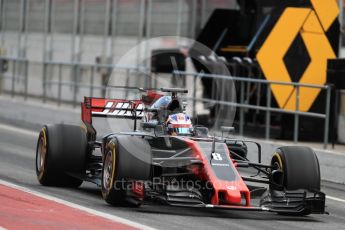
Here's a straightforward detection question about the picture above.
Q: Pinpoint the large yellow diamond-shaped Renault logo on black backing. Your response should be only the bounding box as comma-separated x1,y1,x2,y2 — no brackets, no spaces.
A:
257,0,339,111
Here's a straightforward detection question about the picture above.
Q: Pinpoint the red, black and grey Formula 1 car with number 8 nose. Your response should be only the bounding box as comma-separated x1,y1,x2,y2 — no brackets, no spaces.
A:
36,87,325,215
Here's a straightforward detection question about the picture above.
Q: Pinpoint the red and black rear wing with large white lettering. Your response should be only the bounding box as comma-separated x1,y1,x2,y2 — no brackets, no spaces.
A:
81,97,144,125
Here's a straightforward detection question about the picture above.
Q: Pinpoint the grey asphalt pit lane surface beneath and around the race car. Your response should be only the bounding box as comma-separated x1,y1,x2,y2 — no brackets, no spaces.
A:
0,126,345,230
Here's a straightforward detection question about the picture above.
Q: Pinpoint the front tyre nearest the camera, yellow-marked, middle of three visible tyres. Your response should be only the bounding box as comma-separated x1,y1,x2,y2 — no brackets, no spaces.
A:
102,136,152,207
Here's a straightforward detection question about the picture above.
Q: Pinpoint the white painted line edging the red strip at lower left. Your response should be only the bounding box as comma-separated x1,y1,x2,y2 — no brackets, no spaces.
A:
0,179,154,230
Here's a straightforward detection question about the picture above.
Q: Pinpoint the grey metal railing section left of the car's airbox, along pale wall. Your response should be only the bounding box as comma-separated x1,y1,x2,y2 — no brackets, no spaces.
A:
0,57,149,106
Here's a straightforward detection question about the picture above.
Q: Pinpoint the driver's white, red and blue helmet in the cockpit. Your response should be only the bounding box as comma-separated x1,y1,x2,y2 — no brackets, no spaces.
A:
166,113,193,136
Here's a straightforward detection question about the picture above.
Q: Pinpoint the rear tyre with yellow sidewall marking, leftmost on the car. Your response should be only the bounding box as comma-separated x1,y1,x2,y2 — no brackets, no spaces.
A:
36,124,88,187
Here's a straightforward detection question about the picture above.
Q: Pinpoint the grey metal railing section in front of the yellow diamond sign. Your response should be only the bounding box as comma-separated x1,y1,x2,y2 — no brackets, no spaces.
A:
174,71,333,149
